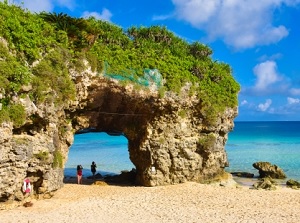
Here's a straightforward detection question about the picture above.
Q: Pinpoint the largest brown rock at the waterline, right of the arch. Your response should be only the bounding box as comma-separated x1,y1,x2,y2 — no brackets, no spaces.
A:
252,162,286,179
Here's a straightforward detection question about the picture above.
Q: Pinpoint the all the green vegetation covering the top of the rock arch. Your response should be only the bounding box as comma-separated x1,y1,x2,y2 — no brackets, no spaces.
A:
0,1,240,126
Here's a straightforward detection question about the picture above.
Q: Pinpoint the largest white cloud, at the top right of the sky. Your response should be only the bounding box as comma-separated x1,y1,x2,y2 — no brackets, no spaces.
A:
172,0,300,49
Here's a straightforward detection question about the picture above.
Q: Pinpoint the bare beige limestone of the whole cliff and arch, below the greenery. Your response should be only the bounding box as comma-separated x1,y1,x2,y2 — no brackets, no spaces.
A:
0,66,237,201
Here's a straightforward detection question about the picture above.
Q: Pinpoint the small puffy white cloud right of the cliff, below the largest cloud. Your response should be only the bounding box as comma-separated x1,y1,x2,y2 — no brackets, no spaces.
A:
253,60,281,91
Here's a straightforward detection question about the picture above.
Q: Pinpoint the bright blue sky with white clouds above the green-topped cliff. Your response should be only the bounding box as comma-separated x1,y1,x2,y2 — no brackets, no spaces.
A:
9,0,300,121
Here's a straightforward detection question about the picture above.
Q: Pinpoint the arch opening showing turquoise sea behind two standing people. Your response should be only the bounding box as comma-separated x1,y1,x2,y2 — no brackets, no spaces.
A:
64,131,135,179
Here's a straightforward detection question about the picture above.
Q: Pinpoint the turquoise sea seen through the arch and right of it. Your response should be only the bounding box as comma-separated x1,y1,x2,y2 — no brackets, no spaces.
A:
64,121,300,180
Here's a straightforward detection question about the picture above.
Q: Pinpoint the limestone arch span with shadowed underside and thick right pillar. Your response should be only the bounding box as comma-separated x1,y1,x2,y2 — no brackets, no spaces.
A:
69,78,237,186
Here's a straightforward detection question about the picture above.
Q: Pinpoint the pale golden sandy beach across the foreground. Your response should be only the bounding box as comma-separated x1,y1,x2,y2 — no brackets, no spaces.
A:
0,179,300,223
